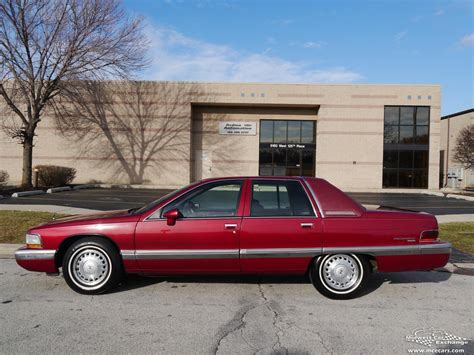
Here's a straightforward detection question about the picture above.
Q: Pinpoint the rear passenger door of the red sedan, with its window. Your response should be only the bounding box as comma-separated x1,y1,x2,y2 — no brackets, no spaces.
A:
240,179,323,273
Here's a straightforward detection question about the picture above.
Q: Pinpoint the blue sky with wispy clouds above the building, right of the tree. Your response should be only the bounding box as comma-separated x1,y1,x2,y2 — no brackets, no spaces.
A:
125,0,474,114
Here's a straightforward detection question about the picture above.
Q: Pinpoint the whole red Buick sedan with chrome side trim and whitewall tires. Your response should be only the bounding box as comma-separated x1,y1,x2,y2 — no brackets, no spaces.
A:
15,177,451,299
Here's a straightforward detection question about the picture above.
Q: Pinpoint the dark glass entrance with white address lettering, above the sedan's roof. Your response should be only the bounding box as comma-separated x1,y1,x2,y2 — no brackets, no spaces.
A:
259,120,316,176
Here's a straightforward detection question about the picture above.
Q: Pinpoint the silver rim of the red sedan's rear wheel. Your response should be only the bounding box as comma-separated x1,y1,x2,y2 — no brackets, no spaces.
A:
320,254,363,293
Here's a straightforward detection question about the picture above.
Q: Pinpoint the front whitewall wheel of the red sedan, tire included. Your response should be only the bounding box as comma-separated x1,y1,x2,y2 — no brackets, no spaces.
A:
62,237,123,295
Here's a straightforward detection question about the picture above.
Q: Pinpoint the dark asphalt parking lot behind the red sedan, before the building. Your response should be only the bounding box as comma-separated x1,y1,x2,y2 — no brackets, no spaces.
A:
0,188,474,215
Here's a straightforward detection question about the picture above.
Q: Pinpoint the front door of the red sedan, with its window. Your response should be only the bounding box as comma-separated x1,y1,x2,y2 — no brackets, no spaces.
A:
135,179,244,273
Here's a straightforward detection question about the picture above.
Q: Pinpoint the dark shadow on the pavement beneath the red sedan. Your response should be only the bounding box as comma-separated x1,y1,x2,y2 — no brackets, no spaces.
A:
110,271,451,296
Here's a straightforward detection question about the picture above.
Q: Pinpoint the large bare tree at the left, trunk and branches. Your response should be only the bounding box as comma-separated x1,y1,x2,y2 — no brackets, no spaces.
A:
0,0,146,186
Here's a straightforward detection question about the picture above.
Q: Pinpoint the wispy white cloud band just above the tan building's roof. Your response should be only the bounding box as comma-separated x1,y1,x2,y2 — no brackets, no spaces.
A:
145,26,363,83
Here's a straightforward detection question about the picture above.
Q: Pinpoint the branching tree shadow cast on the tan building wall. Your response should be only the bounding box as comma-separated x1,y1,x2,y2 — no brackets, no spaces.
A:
55,81,198,184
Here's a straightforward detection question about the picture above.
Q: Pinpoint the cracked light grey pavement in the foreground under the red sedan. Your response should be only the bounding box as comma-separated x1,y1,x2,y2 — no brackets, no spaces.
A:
0,259,474,354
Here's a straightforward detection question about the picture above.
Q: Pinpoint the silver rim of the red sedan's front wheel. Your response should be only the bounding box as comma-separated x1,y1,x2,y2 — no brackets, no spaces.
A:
68,246,112,290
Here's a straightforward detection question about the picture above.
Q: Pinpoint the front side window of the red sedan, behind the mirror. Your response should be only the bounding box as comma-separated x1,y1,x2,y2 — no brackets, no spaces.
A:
161,181,242,218
